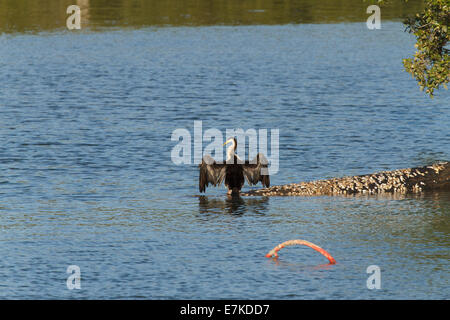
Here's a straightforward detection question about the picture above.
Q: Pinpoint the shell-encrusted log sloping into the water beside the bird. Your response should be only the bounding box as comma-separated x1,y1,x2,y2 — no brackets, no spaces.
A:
241,162,450,196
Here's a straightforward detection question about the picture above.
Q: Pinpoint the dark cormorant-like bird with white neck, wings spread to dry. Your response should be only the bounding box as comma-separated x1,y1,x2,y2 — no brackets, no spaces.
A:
199,138,270,194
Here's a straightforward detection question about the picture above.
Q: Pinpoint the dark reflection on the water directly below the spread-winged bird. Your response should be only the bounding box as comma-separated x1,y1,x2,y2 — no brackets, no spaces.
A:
198,196,269,214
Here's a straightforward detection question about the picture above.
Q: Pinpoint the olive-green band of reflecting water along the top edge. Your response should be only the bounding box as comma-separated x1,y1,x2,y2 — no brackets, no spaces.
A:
0,0,423,33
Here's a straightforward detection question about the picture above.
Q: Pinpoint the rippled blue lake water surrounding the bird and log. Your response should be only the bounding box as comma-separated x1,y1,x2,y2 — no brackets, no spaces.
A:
0,22,450,299
